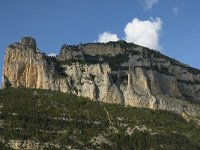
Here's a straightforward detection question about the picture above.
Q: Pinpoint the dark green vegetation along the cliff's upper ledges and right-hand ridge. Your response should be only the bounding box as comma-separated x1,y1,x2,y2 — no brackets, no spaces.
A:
54,41,200,75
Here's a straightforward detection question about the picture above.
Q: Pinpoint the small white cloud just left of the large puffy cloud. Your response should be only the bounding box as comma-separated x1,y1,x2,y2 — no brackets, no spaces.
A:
98,32,119,43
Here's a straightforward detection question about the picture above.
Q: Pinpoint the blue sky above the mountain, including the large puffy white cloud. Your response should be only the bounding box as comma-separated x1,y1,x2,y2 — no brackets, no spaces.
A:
0,0,200,86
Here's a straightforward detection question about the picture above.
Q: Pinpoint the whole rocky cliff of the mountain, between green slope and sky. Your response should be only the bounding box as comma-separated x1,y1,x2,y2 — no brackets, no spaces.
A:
2,37,200,116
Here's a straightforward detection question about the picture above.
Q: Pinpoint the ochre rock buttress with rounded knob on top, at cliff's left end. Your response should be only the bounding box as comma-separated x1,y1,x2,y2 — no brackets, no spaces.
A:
2,37,68,90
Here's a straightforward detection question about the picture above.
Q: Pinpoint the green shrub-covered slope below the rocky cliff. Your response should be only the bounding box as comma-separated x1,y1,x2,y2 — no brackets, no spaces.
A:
0,88,200,149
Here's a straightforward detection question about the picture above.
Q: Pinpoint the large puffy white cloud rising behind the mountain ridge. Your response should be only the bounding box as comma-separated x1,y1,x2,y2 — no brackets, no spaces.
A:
124,18,162,50
